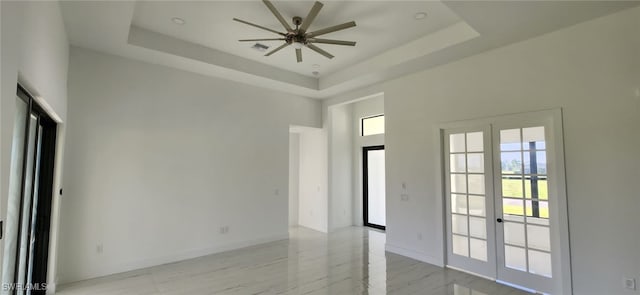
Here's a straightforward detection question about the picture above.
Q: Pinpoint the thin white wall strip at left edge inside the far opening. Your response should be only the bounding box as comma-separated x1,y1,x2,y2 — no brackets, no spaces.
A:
289,132,300,227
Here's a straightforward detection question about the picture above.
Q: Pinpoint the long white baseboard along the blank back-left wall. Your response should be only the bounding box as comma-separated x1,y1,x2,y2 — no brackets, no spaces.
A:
54,232,289,290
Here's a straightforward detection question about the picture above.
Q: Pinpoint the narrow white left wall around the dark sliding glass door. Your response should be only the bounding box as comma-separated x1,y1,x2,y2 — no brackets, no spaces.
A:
0,1,69,294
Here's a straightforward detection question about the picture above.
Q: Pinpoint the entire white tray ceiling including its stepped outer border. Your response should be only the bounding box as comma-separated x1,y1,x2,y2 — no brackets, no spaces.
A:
61,0,640,98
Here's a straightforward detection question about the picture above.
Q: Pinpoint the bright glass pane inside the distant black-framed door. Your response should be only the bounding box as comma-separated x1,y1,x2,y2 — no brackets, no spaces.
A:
367,150,386,226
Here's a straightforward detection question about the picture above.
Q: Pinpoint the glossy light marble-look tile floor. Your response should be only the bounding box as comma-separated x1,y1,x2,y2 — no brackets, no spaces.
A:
58,227,528,295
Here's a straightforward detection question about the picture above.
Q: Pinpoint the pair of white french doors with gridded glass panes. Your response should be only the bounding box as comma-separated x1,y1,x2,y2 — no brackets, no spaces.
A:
443,112,570,294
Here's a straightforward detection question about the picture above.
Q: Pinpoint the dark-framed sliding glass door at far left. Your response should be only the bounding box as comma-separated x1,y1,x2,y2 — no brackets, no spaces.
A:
3,87,56,294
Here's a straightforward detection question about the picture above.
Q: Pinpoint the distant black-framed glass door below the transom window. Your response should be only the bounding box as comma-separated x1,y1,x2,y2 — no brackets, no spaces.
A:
362,145,387,230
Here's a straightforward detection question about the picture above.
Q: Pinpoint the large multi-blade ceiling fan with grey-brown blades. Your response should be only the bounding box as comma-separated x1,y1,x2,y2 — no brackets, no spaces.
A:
233,0,356,62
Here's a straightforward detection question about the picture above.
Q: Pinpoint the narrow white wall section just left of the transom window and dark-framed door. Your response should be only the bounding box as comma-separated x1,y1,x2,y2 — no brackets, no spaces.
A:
328,104,353,231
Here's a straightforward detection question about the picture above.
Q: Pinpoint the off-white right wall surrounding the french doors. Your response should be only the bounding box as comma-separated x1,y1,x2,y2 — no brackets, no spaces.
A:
325,8,640,295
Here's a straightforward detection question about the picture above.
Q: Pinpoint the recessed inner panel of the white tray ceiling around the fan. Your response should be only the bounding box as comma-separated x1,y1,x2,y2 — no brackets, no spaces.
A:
133,1,460,77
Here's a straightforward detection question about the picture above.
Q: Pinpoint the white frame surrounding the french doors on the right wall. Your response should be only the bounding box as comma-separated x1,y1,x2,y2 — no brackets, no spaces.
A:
436,108,573,294
